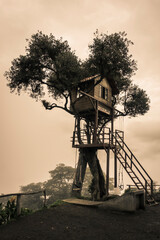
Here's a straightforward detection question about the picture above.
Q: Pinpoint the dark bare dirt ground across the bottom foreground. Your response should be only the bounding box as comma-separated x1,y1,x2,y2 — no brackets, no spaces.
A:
0,203,160,240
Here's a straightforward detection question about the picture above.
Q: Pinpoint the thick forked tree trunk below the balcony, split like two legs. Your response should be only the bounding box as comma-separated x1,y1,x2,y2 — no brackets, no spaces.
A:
72,148,106,200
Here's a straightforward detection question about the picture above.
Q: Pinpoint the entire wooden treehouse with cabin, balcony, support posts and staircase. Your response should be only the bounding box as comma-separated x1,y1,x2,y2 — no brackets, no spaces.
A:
70,75,153,201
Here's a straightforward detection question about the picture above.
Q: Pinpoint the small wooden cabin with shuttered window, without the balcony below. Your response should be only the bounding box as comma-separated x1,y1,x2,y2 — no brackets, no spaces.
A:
70,75,118,120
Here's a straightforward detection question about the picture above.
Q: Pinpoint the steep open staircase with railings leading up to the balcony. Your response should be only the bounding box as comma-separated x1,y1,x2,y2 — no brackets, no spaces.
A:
112,130,155,204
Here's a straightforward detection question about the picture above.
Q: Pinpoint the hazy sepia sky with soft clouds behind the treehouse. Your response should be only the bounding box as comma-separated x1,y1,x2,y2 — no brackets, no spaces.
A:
0,0,160,193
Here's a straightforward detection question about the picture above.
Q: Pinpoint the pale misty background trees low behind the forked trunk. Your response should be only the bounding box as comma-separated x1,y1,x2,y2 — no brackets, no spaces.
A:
20,163,102,209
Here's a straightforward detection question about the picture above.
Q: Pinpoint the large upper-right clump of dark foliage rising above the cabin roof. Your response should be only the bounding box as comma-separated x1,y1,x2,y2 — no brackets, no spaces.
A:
84,30,137,91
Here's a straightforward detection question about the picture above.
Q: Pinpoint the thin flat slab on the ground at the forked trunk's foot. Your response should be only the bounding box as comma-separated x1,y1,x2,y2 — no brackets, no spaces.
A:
63,198,103,207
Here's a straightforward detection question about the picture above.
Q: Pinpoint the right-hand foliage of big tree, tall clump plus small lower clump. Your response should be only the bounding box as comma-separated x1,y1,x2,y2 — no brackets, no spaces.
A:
83,30,150,118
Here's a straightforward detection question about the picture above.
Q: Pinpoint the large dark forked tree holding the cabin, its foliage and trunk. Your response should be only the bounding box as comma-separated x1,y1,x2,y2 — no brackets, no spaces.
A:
5,31,149,199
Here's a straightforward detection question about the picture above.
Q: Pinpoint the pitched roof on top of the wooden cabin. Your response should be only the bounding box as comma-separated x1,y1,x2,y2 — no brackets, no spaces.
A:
80,74,119,95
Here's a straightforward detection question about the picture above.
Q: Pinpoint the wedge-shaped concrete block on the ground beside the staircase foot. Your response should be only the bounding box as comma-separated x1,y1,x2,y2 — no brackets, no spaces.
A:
100,191,145,212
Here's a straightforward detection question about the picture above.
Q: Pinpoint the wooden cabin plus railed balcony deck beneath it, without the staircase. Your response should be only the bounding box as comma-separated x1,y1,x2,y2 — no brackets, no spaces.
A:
70,75,118,149
